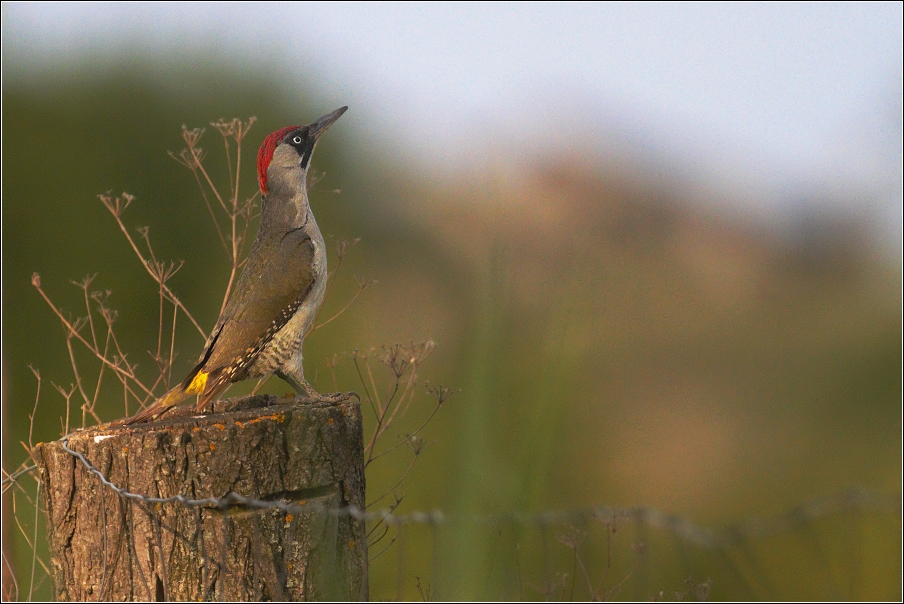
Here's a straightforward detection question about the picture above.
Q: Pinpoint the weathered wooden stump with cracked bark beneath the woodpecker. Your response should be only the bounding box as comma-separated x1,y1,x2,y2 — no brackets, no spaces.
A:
35,395,368,601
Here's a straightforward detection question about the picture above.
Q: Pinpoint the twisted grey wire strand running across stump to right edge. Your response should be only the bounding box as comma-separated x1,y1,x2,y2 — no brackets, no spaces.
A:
60,438,901,549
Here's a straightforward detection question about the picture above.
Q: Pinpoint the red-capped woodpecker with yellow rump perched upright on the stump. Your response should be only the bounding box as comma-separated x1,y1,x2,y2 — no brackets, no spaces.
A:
124,107,348,425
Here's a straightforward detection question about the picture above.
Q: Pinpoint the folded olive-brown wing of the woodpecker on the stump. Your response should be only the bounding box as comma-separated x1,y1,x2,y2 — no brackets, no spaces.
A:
189,229,314,385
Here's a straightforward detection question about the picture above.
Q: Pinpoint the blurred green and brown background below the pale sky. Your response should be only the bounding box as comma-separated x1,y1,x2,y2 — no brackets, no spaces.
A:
3,57,902,600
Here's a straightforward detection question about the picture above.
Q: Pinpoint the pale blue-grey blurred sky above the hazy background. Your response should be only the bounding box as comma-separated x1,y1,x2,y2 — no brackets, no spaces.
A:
2,2,904,247
